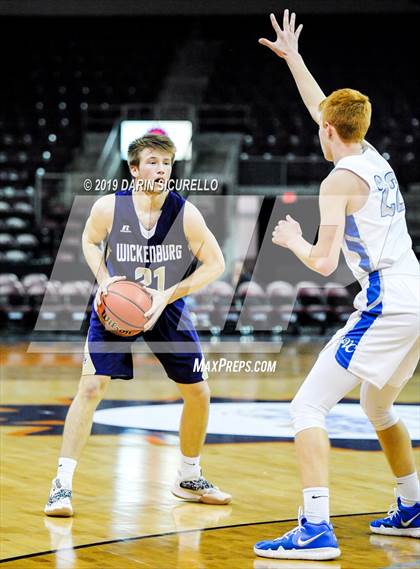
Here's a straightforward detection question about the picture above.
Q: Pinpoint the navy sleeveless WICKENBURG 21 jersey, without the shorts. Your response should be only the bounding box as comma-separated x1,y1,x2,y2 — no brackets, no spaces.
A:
105,190,195,290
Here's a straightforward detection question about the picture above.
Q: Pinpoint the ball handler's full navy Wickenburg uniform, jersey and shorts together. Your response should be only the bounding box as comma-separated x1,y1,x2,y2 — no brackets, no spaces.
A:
83,190,206,383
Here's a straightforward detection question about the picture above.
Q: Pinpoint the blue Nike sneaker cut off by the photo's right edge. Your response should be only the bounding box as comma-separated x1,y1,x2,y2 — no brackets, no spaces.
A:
370,492,420,537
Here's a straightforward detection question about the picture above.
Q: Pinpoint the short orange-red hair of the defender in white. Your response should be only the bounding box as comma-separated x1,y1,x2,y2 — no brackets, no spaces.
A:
319,89,372,142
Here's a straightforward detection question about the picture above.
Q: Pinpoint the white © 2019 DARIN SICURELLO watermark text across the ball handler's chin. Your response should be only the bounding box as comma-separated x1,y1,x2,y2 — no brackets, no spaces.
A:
83,178,219,192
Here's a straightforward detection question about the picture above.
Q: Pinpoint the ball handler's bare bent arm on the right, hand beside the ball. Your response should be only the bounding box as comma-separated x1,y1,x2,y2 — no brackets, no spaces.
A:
144,202,225,331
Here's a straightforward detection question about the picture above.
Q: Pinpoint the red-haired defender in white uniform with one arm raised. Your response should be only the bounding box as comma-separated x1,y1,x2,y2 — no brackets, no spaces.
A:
254,10,420,560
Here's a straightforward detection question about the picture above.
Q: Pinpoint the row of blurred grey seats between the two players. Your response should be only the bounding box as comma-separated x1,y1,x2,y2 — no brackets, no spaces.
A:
194,281,354,335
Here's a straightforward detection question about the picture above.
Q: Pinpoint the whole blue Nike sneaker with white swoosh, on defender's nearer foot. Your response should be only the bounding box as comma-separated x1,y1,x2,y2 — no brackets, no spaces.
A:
254,510,341,561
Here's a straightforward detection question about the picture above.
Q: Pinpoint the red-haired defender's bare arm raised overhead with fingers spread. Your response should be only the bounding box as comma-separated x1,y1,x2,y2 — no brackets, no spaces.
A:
258,10,325,124
